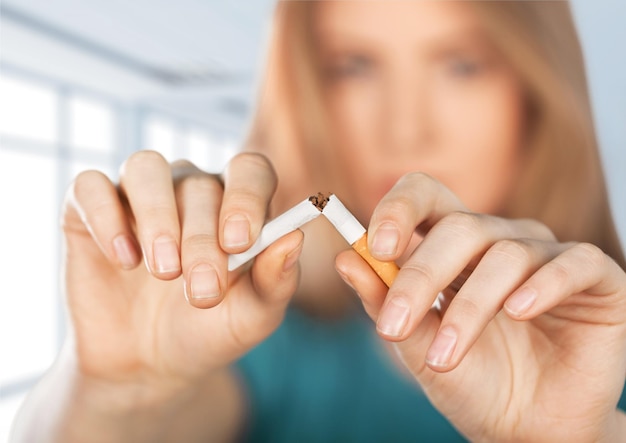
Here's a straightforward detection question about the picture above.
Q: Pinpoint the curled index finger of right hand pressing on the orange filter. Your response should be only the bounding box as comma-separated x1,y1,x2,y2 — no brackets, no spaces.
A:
368,173,466,261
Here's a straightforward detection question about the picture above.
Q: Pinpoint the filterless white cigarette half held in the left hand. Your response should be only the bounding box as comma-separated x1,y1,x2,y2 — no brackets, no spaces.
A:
228,198,322,271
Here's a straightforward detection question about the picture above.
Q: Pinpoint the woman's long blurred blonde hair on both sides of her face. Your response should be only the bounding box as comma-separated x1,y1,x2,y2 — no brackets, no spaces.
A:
248,1,626,268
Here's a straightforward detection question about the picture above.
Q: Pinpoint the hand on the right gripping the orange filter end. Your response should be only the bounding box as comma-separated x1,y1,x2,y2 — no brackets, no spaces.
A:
336,174,626,442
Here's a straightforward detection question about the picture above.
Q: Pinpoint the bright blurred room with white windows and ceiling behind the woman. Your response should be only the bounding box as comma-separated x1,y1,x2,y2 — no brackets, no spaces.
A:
0,0,626,442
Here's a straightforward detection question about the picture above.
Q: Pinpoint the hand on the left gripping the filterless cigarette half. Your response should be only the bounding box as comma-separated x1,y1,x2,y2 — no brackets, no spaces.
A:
63,151,303,392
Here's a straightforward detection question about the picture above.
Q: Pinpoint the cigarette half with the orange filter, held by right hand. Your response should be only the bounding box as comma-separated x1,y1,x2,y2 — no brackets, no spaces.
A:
318,194,400,287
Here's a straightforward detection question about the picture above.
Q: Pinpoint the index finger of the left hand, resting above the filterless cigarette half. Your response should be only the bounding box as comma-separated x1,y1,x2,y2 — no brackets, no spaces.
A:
220,153,277,253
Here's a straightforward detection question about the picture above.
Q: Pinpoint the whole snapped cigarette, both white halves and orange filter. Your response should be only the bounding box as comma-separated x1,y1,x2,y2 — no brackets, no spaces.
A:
228,193,400,286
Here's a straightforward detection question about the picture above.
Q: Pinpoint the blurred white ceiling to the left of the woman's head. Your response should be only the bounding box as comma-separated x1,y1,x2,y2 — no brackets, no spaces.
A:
0,0,275,134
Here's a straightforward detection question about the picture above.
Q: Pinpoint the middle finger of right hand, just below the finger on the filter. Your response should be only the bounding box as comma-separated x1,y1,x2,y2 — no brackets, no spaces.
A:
377,212,547,341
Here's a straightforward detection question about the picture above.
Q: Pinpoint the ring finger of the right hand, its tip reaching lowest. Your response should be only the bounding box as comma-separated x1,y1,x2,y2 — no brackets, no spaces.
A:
426,240,560,371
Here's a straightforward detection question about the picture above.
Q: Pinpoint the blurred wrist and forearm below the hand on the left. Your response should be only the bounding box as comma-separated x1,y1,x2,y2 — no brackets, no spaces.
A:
12,346,244,443
